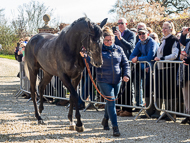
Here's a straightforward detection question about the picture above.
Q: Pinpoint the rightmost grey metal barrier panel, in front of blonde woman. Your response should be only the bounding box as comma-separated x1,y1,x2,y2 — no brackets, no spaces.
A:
154,61,190,122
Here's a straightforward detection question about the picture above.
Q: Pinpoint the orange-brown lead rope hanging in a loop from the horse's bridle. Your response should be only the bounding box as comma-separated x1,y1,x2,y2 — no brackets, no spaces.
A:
84,58,125,101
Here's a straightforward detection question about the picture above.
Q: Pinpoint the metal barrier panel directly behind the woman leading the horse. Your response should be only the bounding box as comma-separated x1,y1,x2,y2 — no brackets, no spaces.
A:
80,61,152,119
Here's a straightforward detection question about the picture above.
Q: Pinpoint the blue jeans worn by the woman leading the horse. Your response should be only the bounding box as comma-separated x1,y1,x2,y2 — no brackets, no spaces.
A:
98,82,121,127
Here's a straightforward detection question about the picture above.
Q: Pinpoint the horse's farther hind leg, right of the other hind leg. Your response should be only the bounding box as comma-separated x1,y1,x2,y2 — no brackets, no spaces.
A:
39,71,52,114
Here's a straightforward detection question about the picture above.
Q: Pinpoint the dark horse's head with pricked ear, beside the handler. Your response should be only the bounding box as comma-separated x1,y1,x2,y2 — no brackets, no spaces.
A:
82,18,107,67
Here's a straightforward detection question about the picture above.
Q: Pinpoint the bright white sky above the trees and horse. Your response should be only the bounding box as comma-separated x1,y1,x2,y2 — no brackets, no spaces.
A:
0,0,116,24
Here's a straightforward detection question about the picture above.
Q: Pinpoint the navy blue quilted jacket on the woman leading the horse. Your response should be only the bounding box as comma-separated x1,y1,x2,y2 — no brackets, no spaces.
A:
96,44,131,84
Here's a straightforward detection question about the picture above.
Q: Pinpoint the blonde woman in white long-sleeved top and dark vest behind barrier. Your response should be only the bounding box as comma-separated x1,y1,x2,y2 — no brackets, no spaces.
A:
154,22,180,120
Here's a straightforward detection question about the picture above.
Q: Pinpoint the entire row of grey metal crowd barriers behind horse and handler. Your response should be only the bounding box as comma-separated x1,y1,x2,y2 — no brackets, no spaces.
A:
16,61,190,122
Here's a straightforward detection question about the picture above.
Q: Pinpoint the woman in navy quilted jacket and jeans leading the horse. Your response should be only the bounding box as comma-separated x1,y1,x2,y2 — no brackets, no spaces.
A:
80,27,130,136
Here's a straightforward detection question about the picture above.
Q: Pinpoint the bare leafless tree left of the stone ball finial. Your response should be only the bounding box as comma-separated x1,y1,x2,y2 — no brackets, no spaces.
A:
12,0,53,34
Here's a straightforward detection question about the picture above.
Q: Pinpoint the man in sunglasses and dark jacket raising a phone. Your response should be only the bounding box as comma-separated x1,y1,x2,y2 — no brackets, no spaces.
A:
112,18,136,117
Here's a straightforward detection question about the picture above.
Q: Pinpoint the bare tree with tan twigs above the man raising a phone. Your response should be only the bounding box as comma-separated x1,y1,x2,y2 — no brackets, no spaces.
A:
109,0,165,21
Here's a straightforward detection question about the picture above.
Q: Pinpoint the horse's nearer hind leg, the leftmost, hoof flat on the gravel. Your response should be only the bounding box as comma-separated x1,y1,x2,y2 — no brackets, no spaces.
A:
28,68,43,123
